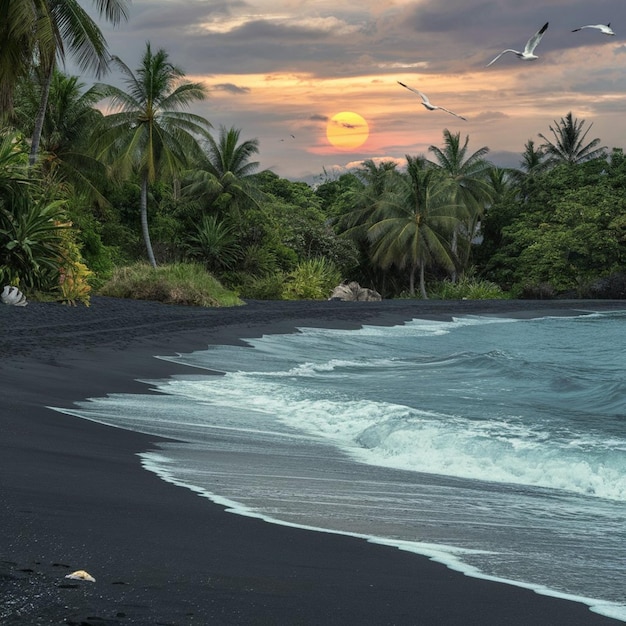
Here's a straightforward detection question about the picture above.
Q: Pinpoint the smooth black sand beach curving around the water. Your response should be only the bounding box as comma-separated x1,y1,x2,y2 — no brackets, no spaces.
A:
0,298,626,626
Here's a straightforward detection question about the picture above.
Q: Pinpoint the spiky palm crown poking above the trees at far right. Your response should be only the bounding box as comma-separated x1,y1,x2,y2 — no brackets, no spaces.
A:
539,111,607,165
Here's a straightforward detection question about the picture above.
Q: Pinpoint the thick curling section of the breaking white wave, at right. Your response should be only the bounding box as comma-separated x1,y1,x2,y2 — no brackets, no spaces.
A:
353,420,626,501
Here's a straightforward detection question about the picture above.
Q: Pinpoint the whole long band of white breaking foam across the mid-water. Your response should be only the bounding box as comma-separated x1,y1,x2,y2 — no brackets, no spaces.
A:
143,368,626,501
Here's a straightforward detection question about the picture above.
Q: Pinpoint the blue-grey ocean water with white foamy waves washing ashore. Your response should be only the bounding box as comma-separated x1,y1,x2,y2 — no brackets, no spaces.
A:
53,311,626,621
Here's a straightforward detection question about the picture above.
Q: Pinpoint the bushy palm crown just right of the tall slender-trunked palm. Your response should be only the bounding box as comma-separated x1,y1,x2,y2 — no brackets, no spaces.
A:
183,126,260,213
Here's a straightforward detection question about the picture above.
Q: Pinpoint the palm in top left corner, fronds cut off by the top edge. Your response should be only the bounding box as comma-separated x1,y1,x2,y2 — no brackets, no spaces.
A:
0,0,127,165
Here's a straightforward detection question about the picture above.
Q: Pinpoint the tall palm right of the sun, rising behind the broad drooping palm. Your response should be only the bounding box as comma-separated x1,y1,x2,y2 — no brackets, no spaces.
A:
428,128,493,280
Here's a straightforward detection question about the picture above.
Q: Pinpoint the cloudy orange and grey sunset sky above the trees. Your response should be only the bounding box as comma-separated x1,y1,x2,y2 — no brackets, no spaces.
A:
72,0,626,184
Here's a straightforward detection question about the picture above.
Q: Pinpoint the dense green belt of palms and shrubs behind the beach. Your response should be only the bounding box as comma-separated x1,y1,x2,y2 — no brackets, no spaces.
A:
0,15,626,306
